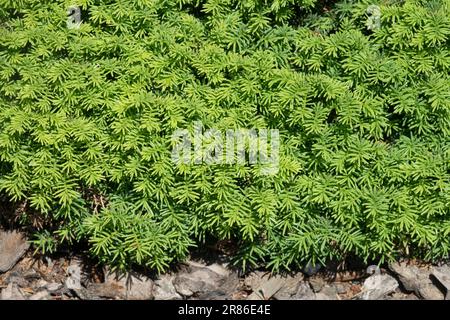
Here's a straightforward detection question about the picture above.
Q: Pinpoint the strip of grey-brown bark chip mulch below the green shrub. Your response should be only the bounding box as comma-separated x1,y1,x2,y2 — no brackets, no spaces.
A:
0,230,450,300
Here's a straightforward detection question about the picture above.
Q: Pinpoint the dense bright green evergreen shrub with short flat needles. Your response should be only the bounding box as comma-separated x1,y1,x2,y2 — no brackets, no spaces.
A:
0,0,450,271
